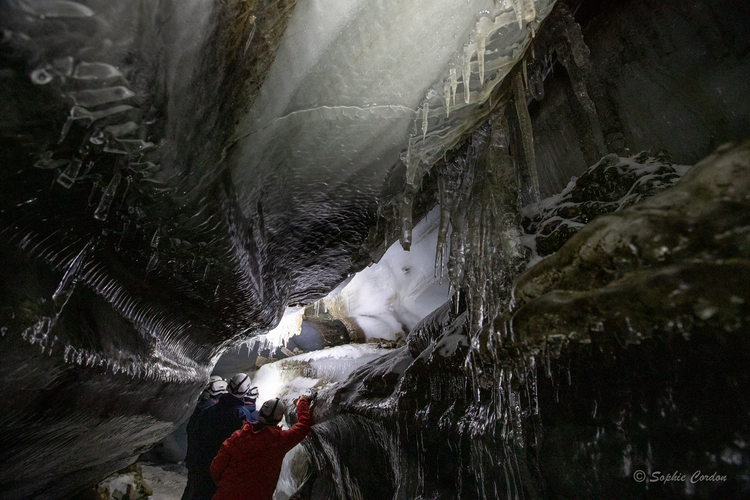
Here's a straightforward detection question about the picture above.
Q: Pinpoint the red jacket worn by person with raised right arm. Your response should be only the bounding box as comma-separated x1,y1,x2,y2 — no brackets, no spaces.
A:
211,399,312,500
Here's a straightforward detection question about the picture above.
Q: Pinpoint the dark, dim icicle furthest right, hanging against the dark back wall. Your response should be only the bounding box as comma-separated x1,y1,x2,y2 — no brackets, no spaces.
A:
549,3,607,163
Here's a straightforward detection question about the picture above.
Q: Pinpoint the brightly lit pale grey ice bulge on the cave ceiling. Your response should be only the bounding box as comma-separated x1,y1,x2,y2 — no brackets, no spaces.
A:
228,0,553,221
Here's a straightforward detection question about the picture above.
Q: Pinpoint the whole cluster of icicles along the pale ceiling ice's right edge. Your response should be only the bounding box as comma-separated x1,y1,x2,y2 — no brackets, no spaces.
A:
398,0,606,336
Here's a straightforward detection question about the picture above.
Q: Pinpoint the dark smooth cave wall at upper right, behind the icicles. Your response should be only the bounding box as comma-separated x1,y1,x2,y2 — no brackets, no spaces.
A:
525,0,750,200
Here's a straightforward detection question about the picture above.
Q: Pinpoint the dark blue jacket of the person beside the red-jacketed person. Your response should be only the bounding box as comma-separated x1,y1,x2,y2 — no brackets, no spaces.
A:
185,394,248,469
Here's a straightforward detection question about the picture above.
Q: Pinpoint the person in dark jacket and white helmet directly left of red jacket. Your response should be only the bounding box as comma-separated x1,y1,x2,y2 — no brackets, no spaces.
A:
183,373,250,500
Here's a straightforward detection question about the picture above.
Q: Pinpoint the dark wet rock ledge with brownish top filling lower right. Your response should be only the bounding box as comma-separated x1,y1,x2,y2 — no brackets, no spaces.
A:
303,143,750,499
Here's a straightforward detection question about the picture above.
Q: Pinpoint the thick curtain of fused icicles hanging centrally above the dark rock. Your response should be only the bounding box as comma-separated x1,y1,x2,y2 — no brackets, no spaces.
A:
435,107,525,331
